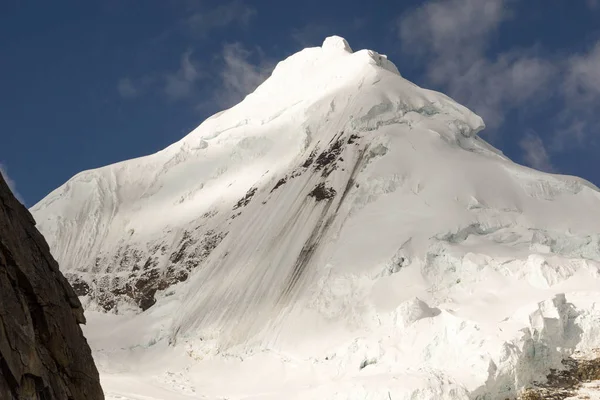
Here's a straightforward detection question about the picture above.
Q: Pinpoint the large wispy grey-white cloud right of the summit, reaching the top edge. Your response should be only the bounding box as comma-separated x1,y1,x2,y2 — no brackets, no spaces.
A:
398,0,557,128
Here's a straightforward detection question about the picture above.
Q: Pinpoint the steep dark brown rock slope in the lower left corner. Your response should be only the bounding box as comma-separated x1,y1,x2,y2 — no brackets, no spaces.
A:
0,175,104,400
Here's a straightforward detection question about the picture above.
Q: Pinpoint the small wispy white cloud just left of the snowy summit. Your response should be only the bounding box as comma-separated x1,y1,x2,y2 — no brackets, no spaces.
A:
215,43,275,107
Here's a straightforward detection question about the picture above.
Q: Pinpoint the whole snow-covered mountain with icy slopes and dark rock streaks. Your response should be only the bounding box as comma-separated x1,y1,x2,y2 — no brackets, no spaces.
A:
31,37,600,399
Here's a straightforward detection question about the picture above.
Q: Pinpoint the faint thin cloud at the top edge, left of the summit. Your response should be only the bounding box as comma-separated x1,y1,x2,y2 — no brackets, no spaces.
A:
185,0,256,37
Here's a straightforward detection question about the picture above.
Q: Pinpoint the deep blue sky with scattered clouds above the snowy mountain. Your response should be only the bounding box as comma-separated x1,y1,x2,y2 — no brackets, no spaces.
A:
0,0,600,206
